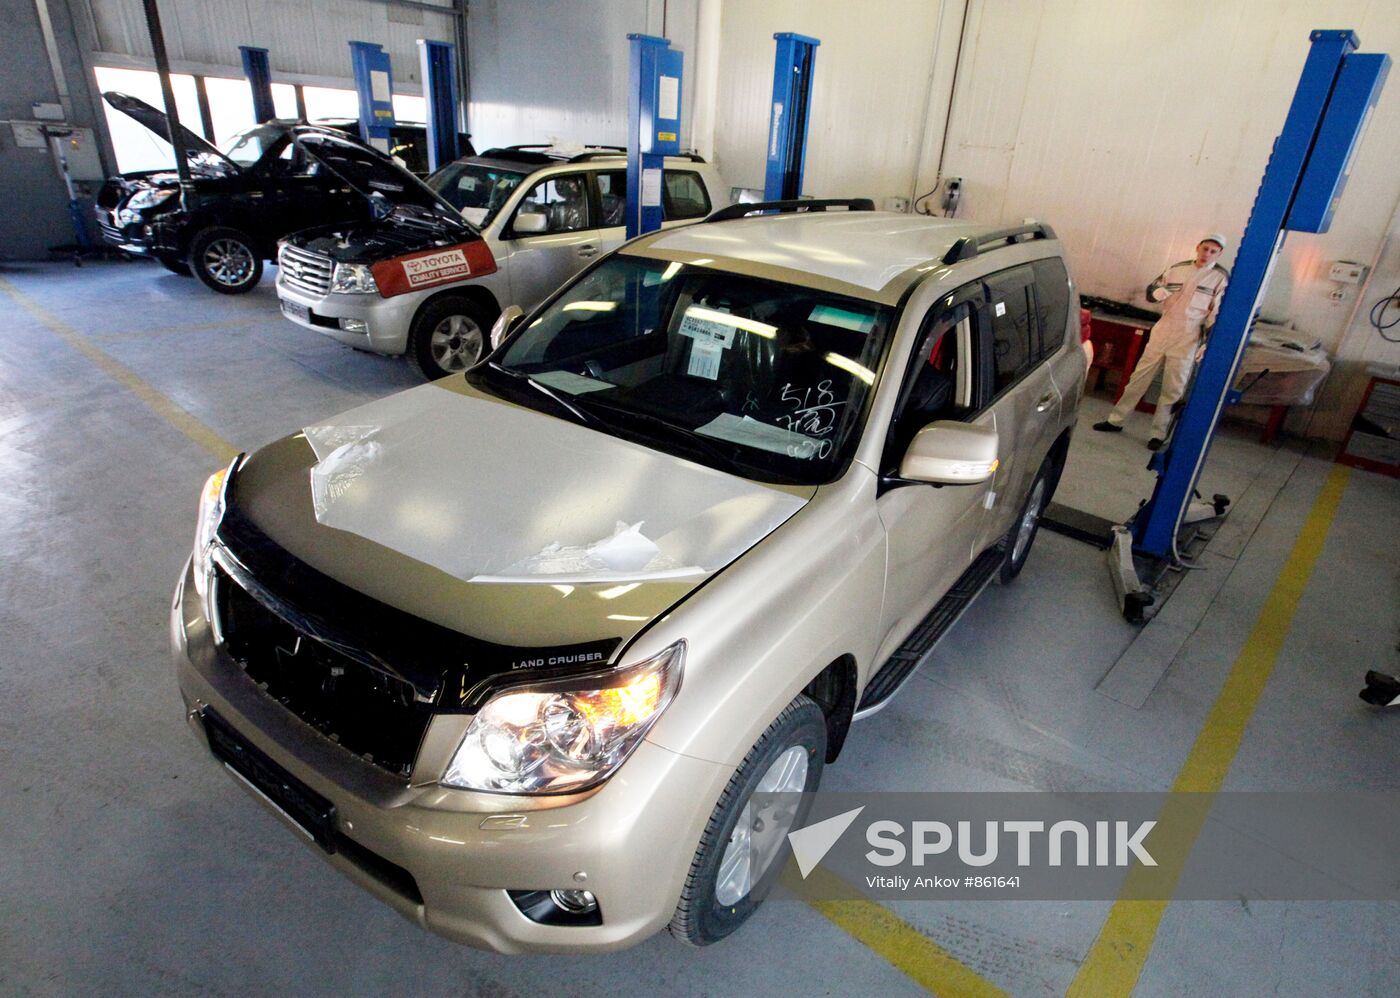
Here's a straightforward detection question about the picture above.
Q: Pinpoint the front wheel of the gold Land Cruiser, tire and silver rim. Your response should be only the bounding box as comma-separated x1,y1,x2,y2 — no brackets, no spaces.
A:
669,696,826,946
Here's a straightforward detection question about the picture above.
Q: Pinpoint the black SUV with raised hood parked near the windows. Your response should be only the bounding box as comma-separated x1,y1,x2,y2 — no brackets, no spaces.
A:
97,92,476,294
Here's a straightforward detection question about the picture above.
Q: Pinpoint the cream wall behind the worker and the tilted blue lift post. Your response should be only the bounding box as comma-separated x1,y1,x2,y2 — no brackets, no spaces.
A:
928,0,1400,438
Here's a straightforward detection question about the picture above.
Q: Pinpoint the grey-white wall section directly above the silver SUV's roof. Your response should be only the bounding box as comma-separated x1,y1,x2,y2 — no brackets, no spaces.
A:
468,0,699,148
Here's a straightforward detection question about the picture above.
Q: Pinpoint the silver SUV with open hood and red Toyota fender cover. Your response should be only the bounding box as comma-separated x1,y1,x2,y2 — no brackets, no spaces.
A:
277,144,729,379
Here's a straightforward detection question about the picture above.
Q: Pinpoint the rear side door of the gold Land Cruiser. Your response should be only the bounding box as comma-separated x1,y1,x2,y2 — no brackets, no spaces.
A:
981,265,1060,546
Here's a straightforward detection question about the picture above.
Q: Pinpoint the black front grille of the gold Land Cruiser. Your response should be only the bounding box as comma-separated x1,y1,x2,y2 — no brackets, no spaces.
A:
216,568,431,777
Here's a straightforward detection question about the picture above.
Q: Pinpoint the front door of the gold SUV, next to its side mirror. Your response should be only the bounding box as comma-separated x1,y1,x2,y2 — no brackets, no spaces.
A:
875,283,1001,661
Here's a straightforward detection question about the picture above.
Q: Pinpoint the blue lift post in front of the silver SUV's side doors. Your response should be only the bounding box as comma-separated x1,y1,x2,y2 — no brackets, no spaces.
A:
626,35,685,239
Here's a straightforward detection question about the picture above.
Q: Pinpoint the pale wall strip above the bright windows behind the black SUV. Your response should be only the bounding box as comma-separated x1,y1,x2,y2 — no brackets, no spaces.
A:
80,0,455,94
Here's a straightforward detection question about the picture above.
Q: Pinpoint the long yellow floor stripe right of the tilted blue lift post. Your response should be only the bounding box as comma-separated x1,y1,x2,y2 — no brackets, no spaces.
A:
1067,465,1351,998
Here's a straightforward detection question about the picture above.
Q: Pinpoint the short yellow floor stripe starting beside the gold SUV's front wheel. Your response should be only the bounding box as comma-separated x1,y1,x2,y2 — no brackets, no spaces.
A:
783,866,1007,998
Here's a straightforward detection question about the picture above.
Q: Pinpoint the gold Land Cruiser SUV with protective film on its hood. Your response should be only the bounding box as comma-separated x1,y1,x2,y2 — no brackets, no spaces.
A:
171,200,1085,952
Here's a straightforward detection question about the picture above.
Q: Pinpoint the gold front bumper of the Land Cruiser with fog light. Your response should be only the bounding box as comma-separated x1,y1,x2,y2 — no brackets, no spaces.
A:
171,565,731,953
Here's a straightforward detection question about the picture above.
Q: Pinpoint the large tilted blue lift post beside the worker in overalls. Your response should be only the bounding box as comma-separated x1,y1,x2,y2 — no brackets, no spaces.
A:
1114,31,1390,620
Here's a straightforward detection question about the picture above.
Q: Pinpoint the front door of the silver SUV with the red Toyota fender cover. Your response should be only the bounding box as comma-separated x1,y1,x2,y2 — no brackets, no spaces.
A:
501,172,601,309
